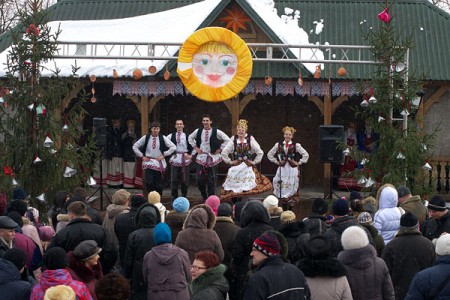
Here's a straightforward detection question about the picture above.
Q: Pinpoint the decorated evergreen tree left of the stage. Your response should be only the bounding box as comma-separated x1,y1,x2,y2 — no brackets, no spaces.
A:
0,0,95,209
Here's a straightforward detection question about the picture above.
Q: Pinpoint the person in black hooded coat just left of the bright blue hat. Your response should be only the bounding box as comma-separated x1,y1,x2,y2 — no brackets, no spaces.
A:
123,203,161,299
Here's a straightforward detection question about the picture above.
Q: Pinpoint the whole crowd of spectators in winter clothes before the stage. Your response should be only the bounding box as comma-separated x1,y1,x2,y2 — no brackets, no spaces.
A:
0,180,450,300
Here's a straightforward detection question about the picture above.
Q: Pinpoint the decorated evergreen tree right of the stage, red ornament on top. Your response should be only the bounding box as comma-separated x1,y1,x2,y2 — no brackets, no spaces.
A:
349,4,434,195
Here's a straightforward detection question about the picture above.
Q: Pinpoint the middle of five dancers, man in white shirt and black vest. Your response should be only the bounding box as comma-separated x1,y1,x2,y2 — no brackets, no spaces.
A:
188,115,230,201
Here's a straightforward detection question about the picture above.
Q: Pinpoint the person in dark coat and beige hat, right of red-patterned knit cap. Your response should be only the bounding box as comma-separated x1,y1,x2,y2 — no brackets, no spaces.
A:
279,210,310,265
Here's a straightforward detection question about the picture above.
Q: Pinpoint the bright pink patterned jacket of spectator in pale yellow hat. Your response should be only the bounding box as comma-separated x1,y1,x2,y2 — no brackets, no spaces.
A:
30,269,92,300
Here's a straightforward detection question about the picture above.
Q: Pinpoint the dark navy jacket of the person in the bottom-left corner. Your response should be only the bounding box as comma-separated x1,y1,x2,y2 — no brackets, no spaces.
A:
0,258,32,300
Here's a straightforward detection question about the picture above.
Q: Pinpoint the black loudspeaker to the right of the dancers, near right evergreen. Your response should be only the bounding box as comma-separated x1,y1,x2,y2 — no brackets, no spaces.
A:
319,125,344,163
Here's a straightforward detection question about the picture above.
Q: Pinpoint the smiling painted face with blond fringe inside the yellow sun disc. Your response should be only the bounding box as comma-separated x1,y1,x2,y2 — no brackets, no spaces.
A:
192,42,238,88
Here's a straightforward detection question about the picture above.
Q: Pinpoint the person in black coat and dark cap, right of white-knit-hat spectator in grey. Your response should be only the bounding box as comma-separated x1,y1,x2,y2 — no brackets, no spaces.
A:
381,212,435,300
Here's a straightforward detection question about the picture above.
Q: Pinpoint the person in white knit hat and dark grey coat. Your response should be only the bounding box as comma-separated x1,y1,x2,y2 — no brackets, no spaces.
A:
338,226,395,300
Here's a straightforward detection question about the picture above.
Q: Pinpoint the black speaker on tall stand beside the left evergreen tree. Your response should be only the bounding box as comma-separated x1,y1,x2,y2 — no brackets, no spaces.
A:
89,118,111,210
